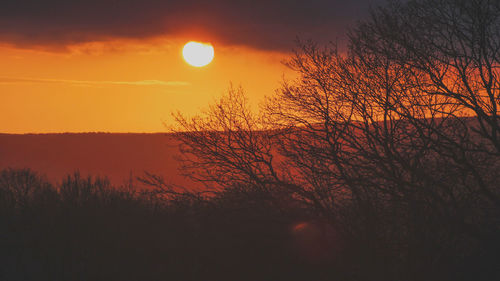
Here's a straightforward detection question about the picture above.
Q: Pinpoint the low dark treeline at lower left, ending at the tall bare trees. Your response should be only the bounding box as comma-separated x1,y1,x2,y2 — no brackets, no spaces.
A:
0,169,335,281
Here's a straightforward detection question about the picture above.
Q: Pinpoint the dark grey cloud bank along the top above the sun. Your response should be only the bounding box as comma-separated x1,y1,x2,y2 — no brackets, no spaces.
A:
0,0,382,49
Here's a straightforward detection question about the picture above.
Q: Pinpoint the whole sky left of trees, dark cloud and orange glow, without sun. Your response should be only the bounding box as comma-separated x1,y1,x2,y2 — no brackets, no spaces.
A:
0,0,383,133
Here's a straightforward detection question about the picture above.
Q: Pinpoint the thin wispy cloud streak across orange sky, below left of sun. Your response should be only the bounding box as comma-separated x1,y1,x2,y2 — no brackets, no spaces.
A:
0,76,189,86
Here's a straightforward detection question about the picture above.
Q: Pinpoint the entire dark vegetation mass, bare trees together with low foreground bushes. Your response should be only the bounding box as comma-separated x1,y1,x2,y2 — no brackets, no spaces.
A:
0,0,500,281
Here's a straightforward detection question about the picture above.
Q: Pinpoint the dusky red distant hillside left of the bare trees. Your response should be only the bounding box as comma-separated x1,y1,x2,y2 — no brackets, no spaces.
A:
0,133,192,187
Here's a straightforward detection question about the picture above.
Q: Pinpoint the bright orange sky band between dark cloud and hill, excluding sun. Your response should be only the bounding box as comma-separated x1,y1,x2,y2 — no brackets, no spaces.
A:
0,38,293,133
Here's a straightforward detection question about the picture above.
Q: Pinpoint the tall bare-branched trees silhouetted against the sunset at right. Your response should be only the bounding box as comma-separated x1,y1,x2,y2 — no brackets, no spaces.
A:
172,0,500,279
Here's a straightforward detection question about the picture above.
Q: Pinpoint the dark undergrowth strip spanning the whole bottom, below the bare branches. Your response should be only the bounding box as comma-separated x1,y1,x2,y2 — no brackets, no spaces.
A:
0,166,500,280
